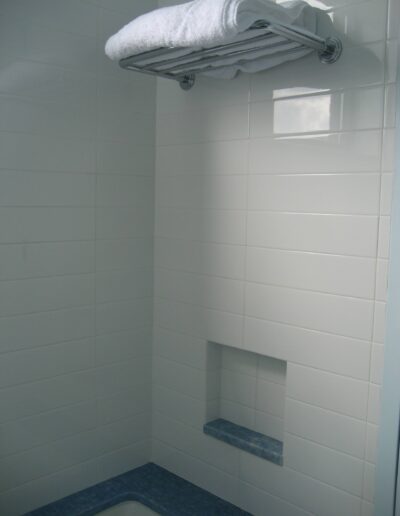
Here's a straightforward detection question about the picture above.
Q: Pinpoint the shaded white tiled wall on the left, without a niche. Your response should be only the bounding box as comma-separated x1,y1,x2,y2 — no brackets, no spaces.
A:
0,0,155,516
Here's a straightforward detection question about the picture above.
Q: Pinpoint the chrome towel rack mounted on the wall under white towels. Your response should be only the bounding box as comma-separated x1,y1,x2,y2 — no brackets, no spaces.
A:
119,20,342,90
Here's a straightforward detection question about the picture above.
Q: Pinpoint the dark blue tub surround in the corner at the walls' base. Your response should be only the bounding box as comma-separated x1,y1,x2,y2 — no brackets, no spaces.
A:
25,463,251,516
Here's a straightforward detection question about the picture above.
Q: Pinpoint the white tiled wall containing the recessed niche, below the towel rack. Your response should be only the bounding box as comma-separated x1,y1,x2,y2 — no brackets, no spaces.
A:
153,0,399,516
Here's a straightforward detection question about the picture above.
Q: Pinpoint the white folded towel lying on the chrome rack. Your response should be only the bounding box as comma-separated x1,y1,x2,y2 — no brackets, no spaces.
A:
105,0,314,60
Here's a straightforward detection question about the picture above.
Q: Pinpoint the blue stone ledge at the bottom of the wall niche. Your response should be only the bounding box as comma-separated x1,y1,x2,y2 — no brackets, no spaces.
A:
203,419,283,466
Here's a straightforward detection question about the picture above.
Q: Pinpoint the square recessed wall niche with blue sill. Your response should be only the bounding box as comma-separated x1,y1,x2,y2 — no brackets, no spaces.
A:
204,343,286,465
